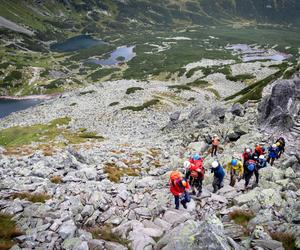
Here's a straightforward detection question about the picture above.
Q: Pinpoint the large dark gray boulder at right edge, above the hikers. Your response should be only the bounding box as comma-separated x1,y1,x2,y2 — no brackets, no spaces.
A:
258,80,300,129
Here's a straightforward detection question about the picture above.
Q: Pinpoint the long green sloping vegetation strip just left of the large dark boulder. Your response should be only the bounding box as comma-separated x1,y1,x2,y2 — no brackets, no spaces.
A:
224,70,283,104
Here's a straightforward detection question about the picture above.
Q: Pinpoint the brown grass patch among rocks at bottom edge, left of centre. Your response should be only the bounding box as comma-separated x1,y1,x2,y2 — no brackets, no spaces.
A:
87,224,129,247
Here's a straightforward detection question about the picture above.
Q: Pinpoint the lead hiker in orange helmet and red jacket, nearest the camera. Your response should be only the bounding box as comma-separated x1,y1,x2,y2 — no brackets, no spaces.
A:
169,171,190,209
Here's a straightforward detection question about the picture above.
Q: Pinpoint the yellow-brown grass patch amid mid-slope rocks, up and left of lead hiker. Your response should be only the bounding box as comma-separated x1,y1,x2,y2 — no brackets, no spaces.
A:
104,163,140,183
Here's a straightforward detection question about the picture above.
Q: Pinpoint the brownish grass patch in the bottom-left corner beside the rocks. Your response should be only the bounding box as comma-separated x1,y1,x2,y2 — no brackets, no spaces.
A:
0,213,23,250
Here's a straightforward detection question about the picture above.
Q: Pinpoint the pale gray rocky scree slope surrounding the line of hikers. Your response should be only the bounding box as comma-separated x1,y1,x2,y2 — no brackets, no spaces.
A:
0,75,300,250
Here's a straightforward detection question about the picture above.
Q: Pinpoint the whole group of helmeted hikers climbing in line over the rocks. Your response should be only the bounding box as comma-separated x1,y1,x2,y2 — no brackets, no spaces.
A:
169,135,285,209
